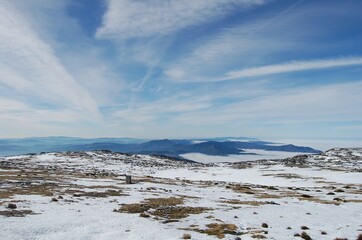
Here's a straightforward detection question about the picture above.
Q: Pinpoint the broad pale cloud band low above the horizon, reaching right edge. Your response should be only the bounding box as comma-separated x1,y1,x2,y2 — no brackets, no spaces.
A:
106,81,362,138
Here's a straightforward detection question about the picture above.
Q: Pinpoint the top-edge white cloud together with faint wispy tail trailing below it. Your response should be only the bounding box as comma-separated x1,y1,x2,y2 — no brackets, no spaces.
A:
96,0,268,92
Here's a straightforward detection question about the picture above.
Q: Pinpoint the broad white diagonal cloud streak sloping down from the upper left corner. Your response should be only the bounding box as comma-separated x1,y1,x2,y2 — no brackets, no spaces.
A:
0,1,99,117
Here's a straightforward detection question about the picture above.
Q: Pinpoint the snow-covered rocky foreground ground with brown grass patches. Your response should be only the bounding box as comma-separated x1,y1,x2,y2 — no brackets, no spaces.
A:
0,148,362,240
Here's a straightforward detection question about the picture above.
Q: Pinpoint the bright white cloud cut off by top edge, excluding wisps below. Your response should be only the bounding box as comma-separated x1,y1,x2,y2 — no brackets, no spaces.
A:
97,0,266,39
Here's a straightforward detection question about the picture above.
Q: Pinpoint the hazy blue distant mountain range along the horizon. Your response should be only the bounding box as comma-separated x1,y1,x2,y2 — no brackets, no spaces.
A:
0,137,320,157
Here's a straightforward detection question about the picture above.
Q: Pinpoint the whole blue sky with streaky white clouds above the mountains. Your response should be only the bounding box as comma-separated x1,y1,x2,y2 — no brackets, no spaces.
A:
0,0,362,142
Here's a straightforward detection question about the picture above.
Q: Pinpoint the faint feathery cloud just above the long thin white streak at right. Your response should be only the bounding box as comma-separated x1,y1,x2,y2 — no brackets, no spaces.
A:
164,16,305,82
